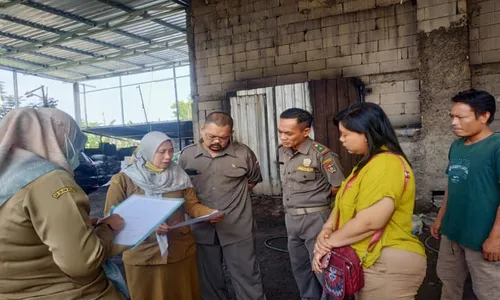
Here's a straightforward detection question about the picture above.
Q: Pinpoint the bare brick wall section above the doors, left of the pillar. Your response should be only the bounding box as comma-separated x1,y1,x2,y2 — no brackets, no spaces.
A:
192,0,420,126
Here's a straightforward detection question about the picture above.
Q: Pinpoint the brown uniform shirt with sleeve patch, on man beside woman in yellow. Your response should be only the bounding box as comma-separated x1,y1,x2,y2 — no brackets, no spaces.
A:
278,138,344,208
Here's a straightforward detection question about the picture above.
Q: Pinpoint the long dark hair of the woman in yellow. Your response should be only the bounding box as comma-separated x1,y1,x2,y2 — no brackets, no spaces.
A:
334,102,410,173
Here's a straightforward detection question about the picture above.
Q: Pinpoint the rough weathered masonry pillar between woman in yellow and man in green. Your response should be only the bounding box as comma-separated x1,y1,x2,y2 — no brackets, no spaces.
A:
413,0,471,203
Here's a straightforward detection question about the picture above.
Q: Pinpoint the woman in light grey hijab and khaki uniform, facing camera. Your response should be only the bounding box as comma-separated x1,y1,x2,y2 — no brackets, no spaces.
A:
104,131,223,300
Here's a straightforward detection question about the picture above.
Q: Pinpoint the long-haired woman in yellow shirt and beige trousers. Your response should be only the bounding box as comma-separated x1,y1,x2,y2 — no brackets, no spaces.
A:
313,103,427,300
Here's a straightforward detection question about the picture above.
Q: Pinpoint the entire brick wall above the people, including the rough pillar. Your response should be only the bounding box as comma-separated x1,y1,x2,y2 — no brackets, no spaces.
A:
191,0,474,203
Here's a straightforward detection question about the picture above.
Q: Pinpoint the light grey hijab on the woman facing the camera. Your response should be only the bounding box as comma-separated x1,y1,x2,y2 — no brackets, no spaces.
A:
123,131,193,197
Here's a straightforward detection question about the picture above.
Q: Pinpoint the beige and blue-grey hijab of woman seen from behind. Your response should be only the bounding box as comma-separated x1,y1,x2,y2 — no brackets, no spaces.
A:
0,108,87,206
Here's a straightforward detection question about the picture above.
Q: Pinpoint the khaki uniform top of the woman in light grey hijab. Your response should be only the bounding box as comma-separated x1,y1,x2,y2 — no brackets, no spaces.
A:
104,173,213,265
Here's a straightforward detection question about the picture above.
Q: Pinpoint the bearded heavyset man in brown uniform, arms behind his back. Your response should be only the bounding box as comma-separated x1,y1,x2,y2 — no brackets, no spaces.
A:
179,112,266,300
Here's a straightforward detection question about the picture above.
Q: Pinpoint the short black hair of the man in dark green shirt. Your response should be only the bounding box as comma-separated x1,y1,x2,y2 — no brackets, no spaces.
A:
451,89,497,124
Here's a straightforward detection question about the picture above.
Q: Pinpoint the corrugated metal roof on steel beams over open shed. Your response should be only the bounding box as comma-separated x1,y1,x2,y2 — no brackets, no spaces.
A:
0,0,189,82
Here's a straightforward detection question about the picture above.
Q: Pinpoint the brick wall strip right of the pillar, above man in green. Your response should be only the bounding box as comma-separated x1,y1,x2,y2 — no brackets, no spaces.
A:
468,0,500,126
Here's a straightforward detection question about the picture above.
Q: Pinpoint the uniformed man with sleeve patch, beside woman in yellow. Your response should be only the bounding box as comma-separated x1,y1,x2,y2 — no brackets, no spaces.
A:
278,108,344,300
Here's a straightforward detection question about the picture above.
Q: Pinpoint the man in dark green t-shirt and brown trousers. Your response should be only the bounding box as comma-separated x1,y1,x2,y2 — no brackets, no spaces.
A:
431,90,500,300
